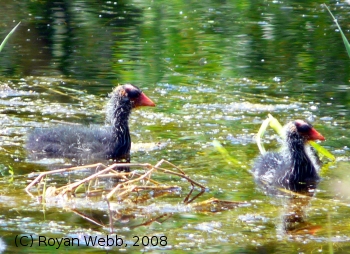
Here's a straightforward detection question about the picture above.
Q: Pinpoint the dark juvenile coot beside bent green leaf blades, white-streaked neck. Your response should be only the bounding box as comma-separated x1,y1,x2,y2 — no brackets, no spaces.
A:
253,120,325,191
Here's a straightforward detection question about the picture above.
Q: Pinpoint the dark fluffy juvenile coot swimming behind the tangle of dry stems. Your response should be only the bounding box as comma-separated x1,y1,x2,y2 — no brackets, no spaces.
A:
26,84,155,162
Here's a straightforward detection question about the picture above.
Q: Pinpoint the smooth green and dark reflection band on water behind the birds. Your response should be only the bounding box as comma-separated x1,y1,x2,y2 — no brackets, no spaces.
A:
0,1,349,84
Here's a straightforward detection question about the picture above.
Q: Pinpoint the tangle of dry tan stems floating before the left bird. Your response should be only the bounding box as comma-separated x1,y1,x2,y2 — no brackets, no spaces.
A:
25,160,206,203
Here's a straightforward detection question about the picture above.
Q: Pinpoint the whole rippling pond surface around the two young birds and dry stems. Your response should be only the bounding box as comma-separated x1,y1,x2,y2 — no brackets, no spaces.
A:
0,0,350,253
